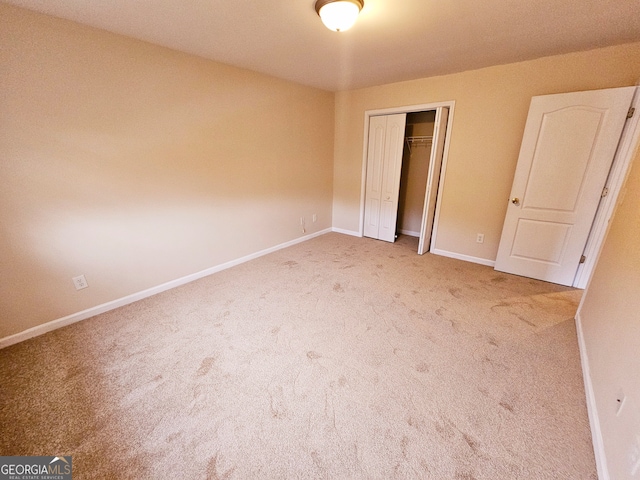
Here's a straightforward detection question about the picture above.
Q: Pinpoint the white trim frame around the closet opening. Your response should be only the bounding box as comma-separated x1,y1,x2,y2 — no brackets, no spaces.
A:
358,100,456,251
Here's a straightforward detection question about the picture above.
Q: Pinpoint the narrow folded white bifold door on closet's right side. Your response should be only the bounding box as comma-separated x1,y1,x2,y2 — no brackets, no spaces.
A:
418,107,449,255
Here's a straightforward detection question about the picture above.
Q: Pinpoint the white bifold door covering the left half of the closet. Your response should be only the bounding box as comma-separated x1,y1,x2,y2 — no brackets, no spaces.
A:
364,113,407,242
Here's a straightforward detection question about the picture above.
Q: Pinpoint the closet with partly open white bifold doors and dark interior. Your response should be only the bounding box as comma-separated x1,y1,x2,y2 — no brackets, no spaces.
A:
361,102,453,254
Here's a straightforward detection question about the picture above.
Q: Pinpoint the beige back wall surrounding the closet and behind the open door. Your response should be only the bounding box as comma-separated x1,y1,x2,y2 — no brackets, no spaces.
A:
333,43,640,261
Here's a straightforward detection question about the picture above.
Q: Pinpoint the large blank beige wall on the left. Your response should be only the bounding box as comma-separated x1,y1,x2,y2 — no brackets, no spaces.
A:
0,3,334,338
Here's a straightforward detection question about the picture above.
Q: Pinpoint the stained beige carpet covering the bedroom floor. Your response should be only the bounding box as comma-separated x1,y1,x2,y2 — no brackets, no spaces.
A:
0,233,597,480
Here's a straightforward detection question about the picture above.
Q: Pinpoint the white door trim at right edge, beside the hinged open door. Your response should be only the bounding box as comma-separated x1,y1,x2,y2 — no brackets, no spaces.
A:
573,86,640,288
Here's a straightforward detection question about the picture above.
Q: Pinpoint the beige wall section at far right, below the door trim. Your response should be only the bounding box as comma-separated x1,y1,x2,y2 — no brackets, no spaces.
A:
580,146,640,478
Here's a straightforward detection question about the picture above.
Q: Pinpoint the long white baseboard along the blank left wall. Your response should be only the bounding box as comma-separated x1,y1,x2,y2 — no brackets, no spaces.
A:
0,228,332,349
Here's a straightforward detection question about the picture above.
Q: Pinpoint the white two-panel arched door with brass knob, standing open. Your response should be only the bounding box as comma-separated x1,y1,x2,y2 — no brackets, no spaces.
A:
495,87,635,285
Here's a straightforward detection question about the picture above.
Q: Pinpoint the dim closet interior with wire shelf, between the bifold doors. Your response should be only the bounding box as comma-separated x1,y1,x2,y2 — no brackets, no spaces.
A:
397,110,436,237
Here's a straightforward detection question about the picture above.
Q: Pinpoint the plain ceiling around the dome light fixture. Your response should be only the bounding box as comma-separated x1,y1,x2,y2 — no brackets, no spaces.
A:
3,0,640,91
